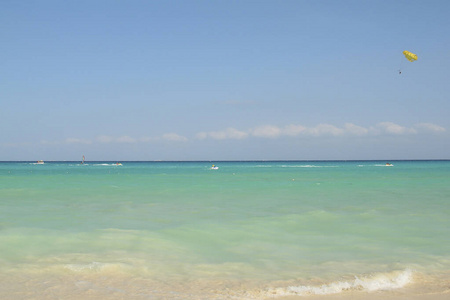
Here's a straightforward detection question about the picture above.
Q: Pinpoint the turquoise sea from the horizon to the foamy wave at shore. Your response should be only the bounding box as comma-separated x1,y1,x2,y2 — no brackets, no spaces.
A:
0,161,450,299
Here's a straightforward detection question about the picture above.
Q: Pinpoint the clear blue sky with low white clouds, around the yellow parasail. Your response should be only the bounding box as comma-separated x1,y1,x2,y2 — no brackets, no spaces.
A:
0,0,450,161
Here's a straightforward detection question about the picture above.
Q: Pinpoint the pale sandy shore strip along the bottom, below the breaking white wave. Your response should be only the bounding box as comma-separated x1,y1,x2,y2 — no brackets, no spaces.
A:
0,270,450,300
